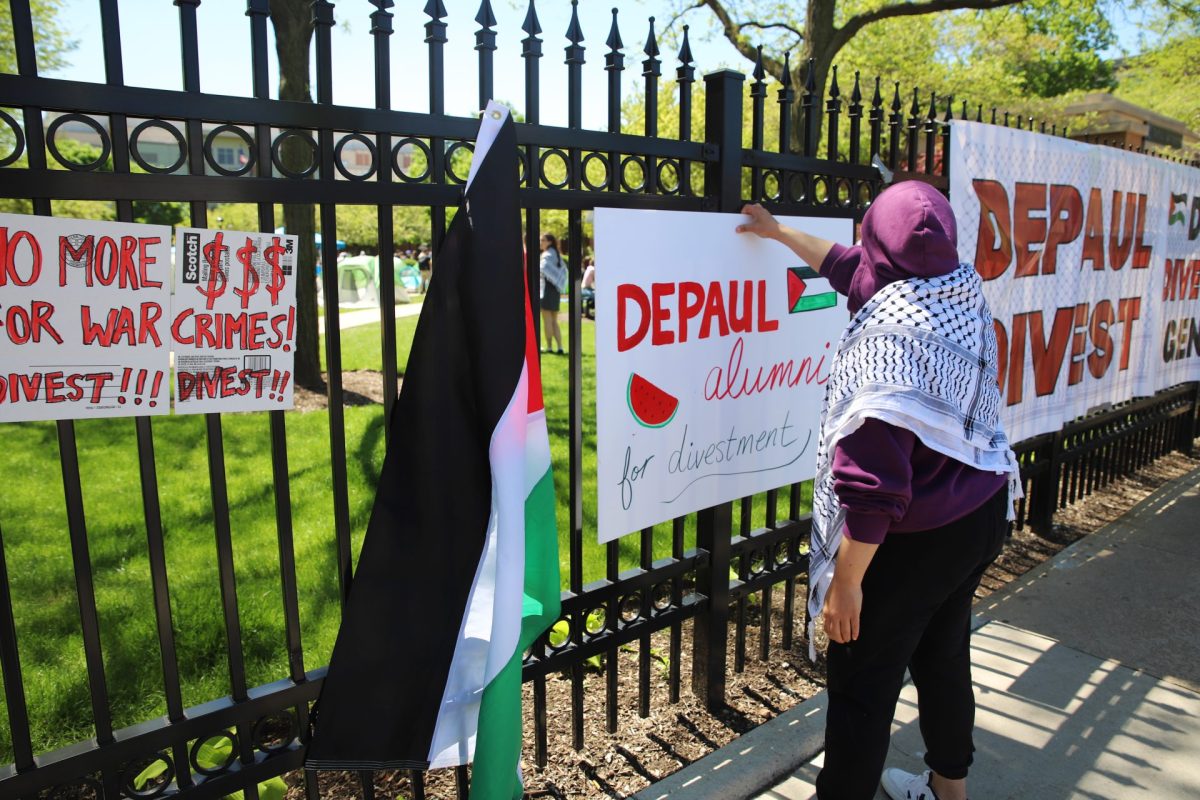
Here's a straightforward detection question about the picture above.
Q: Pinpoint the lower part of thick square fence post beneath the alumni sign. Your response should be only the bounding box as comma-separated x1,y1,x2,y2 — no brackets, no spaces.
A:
691,503,733,711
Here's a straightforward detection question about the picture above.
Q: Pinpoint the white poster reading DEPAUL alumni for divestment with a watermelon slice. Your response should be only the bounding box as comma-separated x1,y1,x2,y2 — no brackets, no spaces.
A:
595,209,853,542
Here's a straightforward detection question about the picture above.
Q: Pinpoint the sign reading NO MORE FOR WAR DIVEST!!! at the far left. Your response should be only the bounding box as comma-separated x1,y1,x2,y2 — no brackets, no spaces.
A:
0,213,170,422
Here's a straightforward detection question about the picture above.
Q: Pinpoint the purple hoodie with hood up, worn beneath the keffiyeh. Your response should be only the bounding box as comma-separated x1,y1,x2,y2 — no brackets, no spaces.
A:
818,181,1006,545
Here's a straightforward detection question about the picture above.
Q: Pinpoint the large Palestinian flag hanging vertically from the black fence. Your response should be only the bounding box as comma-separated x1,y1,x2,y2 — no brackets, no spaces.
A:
305,103,559,800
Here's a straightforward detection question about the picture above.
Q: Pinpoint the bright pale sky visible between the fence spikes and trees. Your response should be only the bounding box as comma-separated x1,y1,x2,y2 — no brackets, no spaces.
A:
47,0,1152,130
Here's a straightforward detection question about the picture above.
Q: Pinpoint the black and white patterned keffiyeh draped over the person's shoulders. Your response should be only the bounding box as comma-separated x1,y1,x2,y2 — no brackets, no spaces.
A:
808,264,1022,658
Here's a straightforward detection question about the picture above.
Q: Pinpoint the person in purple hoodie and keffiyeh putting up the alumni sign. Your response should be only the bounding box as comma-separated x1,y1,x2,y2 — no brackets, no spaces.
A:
737,181,1020,800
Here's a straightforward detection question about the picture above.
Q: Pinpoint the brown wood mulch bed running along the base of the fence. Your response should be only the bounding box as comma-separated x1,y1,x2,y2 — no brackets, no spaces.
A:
284,383,1200,800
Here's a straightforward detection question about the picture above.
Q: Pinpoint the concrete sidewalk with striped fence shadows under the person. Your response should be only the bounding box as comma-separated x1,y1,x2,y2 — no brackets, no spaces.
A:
637,462,1200,800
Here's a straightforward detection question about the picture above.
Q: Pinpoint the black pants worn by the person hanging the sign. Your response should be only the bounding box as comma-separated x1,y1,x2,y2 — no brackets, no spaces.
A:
817,487,1008,800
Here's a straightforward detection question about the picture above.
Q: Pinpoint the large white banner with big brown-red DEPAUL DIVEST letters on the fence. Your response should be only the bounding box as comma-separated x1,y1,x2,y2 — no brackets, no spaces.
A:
950,121,1200,441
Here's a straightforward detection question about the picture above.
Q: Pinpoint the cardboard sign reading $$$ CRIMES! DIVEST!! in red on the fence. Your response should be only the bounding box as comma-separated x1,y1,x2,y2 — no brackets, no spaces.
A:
170,228,296,414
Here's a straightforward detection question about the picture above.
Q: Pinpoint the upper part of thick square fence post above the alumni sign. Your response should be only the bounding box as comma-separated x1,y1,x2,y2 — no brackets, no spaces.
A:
704,70,745,212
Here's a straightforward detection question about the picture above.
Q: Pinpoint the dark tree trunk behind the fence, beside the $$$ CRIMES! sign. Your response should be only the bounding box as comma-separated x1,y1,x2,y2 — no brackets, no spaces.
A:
271,0,324,390
